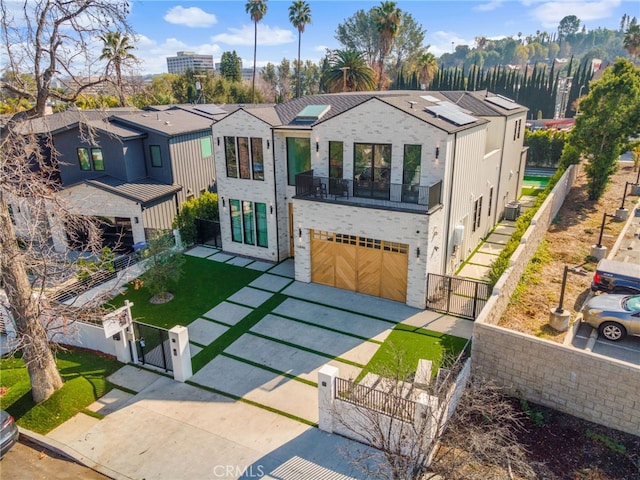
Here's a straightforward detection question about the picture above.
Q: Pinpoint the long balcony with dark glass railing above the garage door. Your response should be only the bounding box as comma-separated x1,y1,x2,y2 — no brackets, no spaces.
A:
296,170,442,212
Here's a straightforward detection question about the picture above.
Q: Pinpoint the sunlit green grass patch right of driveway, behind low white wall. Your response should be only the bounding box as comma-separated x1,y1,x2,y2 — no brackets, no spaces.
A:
358,324,467,380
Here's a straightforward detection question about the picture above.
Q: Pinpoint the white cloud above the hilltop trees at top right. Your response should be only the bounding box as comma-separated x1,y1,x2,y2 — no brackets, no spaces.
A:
530,0,620,28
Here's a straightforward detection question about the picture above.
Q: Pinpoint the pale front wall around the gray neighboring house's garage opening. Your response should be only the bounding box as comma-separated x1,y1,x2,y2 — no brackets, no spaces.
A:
50,184,145,252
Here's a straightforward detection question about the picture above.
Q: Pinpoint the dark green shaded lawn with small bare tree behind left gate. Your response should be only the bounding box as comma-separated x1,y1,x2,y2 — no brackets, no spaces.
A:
110,255,262,328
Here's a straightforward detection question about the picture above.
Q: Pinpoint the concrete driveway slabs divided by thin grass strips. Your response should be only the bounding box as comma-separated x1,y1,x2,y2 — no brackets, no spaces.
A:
42,247,473,480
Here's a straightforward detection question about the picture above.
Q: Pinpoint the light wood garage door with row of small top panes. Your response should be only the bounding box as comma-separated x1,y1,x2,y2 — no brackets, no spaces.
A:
311,230,409,303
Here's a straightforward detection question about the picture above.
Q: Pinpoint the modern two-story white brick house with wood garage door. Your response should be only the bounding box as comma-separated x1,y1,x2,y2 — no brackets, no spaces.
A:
213,91,527,307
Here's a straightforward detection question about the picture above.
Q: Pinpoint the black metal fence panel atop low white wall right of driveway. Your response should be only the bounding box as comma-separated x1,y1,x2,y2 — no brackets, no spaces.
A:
335,377,416,422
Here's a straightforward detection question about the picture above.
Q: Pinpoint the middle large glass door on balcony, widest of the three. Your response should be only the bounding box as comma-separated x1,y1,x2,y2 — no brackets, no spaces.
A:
353,143,391,199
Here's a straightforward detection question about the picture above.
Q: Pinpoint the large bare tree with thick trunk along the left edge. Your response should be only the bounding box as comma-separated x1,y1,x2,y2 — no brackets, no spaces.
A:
0,0,129,403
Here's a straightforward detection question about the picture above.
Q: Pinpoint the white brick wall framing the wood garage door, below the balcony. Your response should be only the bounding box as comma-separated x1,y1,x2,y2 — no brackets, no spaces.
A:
294,200,443,308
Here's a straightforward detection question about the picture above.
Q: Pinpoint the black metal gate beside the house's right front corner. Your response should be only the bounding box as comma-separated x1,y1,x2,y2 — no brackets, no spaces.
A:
427,273,492,320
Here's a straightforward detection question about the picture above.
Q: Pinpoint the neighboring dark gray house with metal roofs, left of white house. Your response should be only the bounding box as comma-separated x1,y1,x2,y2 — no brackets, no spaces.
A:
10,109,215,252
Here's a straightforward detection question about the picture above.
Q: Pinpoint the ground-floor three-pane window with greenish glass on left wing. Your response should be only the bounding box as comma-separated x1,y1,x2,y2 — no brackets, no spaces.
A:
229,200,269,248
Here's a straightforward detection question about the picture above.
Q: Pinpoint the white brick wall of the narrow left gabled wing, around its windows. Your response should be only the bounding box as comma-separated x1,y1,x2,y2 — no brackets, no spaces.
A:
213,110,280,262
